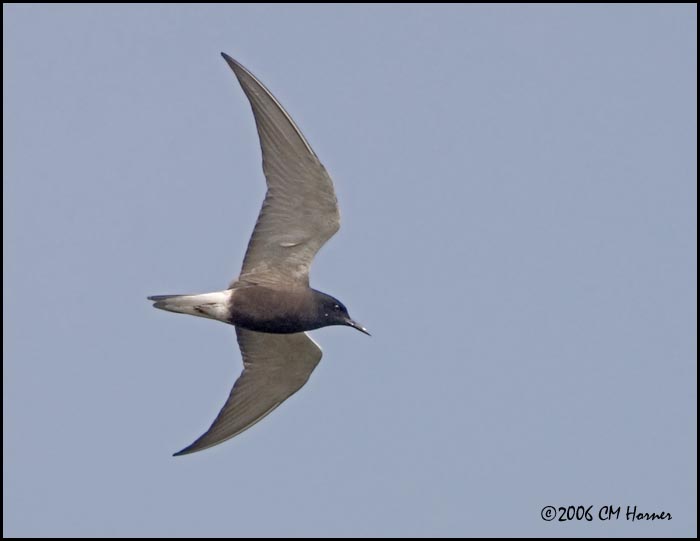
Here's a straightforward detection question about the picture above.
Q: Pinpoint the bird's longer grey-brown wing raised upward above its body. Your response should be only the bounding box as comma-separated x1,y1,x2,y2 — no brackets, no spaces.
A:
221,53,340,286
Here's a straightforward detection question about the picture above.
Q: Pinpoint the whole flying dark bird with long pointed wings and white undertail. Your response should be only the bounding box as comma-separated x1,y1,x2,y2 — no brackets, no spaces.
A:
148,53,369,456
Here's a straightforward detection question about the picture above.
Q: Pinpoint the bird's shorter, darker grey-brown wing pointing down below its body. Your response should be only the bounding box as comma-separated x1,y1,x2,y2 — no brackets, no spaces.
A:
175,327,321,456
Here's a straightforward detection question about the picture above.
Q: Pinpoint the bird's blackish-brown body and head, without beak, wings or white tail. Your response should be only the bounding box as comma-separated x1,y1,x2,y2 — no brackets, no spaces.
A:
229,286,348,334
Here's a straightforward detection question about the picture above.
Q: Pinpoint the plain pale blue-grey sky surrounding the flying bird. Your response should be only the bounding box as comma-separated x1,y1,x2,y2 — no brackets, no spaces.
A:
3,5,697,537
